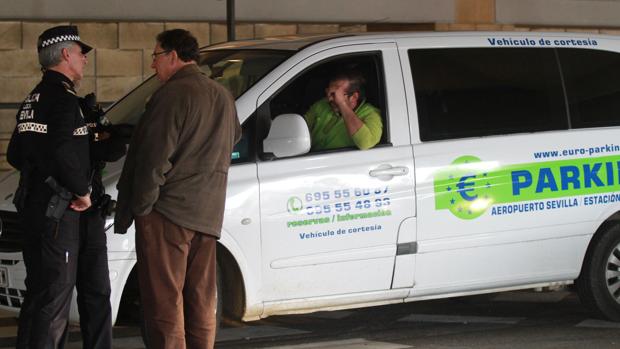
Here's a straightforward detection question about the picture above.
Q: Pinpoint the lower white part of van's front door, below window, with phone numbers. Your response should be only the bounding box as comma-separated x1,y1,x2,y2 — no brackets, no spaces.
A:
258,147,413,301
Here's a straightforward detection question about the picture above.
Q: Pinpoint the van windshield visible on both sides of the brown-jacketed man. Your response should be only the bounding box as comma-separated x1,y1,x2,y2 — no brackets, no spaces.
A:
105,49,295,125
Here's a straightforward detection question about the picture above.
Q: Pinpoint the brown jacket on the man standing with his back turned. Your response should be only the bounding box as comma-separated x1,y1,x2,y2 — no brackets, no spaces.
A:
114,64,241,238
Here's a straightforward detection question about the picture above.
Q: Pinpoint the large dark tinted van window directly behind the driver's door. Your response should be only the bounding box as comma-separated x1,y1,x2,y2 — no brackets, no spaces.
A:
409,48,568,141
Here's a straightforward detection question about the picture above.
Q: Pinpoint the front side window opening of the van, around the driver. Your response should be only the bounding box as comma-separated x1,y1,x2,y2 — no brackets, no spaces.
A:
259,52,388,152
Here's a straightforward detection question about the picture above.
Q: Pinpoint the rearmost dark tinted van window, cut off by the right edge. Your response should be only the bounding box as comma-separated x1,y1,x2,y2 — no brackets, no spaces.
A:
558,49,620,128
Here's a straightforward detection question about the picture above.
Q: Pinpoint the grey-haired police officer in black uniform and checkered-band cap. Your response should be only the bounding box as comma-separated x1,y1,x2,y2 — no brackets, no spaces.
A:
7,26,111,348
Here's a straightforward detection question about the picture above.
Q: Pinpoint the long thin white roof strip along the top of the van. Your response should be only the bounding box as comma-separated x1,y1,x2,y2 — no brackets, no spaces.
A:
203,31,620,51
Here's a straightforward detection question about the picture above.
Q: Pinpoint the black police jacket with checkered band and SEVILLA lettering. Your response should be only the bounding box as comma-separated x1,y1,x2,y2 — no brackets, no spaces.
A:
7,70,90,201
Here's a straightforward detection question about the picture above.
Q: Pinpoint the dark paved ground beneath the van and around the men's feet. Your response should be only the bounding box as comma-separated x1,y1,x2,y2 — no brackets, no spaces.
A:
0,291,620,349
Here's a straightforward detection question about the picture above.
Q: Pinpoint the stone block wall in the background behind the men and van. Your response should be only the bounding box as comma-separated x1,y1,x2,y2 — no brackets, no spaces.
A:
0,0,620,170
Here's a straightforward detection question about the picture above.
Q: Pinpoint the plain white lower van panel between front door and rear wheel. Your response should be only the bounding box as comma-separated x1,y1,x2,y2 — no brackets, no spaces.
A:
411,235,590,297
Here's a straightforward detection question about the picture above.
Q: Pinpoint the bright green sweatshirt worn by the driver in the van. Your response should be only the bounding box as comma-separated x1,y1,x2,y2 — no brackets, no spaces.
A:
305,98,383,151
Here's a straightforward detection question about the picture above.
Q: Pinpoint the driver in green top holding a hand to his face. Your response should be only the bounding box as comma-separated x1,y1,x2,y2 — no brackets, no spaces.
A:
305,70,383,151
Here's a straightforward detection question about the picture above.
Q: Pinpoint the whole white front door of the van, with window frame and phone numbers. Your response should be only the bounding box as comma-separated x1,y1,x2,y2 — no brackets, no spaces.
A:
258,42,415,303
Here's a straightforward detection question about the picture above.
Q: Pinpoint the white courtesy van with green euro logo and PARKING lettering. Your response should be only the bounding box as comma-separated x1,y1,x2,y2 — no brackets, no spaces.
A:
0,32,620,321
